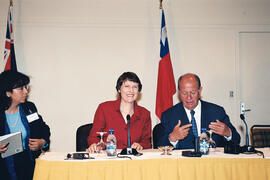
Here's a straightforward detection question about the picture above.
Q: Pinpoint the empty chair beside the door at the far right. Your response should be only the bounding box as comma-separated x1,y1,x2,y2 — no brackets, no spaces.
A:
250,125,270,148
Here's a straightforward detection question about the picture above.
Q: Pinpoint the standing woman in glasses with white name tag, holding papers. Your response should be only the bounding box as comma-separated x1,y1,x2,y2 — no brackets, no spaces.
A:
0,71,50,180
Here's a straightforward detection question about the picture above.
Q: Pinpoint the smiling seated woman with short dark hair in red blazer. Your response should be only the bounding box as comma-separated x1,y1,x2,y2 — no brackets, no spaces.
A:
87,72,152,153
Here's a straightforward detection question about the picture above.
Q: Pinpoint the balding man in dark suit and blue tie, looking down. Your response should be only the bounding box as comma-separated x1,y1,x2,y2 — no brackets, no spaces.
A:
158,73,240,149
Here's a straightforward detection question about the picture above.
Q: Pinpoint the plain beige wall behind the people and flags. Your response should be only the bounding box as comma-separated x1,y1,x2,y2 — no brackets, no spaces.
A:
0,0,270,151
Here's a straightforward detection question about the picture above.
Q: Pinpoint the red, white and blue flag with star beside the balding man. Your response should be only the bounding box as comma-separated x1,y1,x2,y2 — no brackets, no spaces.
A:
156,9,176,119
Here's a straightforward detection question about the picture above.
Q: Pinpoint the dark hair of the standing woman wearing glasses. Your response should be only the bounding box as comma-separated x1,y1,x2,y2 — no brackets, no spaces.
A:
0,70,30,109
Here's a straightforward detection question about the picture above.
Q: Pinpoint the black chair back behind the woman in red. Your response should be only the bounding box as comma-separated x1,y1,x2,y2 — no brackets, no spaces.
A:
76,123,93,152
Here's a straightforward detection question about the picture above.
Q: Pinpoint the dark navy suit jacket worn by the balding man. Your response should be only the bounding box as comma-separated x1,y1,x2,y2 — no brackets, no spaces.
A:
158,101,240,149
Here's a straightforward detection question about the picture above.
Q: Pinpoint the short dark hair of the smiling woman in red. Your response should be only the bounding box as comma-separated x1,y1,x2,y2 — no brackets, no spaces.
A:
116,72,142,92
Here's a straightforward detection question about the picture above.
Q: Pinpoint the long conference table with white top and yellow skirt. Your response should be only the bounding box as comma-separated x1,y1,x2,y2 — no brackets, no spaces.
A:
33,148,270,180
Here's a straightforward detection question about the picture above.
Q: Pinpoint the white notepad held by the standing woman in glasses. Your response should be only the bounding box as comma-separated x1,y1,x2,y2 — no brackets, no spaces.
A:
0,132,23,158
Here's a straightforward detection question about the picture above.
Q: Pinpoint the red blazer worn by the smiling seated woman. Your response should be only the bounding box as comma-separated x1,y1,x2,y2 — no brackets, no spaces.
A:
88,99,152,149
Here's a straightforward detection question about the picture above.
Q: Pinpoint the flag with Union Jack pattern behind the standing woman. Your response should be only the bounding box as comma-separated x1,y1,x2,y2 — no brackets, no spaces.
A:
4,3,17,71
